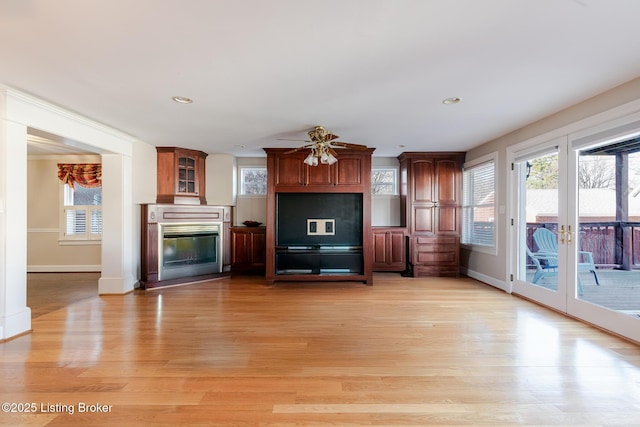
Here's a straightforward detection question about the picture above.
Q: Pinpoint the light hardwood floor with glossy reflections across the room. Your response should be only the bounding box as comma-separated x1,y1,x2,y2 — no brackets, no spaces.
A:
0,274,640,426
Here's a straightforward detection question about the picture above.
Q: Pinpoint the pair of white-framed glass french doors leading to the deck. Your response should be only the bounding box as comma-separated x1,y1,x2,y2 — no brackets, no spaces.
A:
509,131,640,341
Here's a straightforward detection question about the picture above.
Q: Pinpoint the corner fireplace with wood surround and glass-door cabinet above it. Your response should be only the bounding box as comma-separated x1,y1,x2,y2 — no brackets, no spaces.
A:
140,147,233,289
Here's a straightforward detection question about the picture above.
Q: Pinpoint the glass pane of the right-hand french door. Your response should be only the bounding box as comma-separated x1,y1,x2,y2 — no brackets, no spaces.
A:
576,149,640,318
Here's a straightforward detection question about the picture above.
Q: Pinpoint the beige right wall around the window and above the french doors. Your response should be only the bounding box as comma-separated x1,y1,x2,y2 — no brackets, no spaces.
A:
460,78,640,287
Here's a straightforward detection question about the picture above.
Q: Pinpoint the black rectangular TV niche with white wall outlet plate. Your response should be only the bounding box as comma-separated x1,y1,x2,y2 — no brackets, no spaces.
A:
276,193,362,247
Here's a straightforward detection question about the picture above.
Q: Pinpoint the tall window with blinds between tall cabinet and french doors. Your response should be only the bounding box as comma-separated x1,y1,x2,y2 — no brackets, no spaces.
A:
462,155,496,248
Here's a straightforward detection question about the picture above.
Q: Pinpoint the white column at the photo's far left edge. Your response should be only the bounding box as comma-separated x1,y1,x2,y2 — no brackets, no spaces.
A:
0,106,31,340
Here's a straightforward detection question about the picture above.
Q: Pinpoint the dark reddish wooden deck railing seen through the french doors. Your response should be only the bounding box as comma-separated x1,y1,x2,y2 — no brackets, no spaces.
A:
527,221,640,269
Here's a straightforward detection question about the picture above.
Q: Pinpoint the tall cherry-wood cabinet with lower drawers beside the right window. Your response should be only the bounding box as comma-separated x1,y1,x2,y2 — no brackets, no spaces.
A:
398,152,464,276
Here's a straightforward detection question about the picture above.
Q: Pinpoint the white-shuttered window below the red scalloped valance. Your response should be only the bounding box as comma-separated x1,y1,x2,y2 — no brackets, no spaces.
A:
63,183,102,240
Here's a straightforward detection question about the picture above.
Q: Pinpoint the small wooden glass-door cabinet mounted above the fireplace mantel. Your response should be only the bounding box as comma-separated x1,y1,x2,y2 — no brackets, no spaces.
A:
156,147,207,205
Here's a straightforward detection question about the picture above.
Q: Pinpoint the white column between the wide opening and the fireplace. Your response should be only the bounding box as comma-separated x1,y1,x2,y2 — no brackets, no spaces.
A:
98,154,137,295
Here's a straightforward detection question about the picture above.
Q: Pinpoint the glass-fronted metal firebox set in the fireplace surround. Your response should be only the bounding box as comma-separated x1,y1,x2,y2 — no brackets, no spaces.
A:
158,223,222,280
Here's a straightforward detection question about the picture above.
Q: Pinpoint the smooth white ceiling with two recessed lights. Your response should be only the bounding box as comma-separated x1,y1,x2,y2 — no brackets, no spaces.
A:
0,0,640,156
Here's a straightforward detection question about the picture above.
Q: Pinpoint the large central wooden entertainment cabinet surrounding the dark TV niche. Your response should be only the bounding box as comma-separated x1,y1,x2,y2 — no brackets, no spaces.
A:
264,148,374,284
